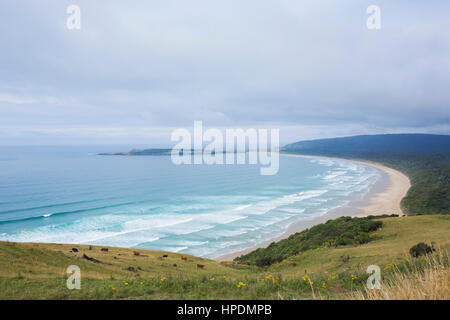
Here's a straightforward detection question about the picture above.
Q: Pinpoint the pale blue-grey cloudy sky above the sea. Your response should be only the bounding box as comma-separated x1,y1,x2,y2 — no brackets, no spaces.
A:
0,0,450,147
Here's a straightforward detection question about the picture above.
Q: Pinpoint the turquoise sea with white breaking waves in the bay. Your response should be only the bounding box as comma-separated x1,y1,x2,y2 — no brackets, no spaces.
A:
0,146,381,258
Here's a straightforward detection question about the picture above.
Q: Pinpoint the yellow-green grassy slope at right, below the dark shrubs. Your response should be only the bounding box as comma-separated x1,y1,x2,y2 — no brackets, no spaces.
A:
266,215,450,276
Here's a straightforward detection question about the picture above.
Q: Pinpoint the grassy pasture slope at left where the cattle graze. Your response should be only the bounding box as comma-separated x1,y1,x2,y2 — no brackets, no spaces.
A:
0,242,246,279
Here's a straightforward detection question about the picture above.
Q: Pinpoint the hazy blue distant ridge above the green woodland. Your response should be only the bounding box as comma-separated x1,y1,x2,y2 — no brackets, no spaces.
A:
282,134,450,155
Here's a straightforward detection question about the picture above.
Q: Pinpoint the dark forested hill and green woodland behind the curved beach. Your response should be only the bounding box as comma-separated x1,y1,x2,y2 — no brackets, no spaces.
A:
282,134,450,214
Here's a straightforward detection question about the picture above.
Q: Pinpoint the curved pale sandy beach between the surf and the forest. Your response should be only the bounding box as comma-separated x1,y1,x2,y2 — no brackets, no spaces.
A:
213,153,411,261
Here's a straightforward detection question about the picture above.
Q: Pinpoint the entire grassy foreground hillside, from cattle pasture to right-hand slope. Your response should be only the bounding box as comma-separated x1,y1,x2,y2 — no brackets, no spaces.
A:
0,215,450,299
